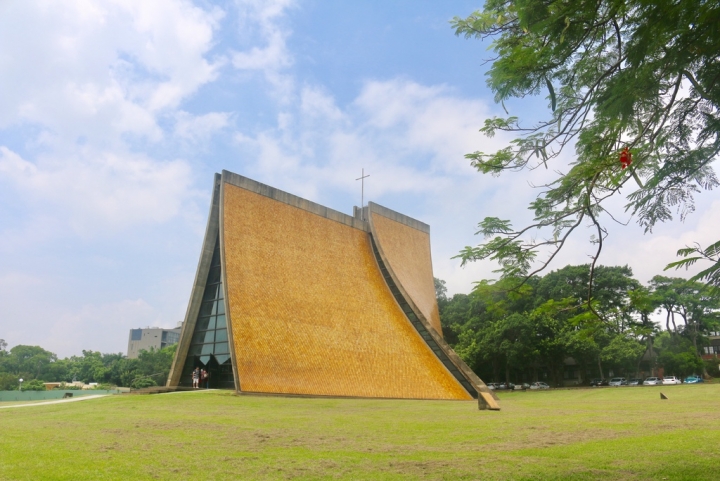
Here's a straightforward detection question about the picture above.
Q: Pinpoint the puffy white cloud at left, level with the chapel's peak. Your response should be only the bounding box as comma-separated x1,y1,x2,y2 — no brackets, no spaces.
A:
0,147,192,237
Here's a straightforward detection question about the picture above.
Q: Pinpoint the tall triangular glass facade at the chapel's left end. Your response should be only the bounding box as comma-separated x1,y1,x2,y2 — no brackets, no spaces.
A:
180,240,235,389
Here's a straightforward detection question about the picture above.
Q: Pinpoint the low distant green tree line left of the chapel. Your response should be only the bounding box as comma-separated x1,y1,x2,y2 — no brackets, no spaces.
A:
0,339,177,391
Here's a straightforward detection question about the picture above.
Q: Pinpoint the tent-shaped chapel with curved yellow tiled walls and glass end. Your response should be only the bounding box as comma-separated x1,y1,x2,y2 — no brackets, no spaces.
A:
167,171,498,409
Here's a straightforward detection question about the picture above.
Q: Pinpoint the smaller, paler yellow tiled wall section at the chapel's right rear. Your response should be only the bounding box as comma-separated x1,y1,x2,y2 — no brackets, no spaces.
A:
371,212,442,336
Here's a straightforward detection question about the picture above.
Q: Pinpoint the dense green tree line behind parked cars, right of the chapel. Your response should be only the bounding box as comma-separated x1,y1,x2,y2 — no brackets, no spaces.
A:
435,265,720,385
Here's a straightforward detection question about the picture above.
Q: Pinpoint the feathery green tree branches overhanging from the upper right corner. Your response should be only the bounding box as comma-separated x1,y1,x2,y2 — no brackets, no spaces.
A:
453,0,720,288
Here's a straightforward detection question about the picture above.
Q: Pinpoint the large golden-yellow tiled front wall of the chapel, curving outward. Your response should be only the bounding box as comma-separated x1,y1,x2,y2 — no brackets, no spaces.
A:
223,184,471,399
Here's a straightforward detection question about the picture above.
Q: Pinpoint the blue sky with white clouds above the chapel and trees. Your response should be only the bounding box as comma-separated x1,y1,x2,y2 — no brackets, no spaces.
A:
0,0,720,357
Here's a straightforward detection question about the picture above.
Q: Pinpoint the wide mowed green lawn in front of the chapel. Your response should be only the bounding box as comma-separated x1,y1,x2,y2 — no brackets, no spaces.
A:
0,384,720,480
